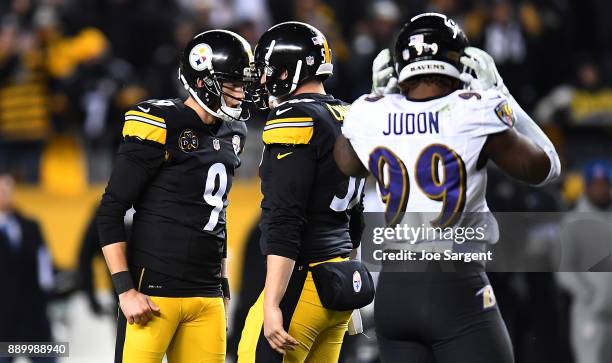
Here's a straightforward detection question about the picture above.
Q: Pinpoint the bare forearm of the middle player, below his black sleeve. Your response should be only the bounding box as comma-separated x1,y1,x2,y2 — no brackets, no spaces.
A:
264,255,295,306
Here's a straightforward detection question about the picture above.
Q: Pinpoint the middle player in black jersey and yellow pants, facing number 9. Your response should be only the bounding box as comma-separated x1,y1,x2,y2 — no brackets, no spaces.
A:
238,22,364,363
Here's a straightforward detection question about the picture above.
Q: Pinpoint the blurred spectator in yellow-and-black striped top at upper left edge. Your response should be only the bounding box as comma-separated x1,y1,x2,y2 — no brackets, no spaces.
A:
0,1,51,182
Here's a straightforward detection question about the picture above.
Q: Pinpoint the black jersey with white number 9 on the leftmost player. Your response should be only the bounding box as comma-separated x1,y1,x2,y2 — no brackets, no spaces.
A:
100,99,246,291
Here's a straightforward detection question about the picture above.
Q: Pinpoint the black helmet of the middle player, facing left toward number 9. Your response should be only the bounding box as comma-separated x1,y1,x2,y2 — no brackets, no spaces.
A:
255,21,334,108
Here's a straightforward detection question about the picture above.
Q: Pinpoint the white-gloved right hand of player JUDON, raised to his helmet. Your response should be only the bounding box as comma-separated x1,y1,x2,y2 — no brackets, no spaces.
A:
459,47,508,95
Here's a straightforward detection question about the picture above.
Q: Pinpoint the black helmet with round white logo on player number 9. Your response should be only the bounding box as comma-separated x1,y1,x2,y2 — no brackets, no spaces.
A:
179,30,257,121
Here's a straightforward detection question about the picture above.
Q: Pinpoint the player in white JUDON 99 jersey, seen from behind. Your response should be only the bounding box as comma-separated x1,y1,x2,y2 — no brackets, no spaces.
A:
335,13,560,363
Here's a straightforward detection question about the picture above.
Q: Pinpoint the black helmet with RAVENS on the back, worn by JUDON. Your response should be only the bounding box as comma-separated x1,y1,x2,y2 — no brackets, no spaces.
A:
393,13,469,82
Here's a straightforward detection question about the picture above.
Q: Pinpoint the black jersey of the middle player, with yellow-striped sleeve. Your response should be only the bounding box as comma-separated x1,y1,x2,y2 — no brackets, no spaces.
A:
259,94,365,263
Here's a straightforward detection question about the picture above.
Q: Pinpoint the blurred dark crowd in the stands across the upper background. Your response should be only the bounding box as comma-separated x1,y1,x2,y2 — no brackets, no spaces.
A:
0,0,612,183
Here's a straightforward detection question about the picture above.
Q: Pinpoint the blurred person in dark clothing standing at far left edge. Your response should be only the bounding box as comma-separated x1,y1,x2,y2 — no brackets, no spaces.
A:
0,171,55,363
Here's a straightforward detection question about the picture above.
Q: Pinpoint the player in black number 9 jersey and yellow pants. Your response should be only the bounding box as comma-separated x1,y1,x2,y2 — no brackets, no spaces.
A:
98,30,253,362
